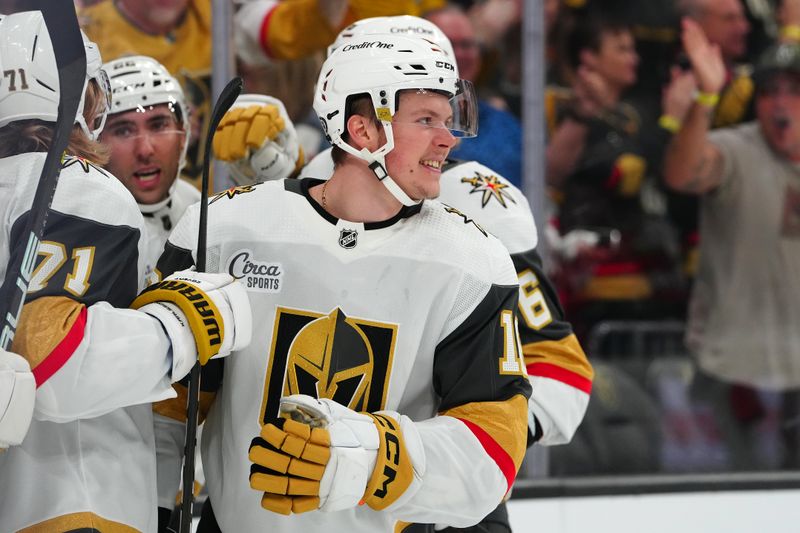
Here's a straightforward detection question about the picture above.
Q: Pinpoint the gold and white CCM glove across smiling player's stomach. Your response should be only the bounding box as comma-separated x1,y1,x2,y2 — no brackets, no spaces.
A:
249,395,425,514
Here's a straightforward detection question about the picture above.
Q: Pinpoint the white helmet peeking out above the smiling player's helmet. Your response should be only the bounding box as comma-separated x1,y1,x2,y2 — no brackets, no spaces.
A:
328,15,458,65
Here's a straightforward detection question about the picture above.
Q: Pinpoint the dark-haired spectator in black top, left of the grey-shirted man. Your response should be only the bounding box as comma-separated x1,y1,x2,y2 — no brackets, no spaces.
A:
546,17,692,333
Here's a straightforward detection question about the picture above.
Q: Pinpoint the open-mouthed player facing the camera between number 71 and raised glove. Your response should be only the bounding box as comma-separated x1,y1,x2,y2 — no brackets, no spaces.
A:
100,56,200,281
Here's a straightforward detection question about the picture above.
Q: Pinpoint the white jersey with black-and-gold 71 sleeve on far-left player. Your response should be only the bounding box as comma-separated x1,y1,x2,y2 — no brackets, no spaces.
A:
0,153,174,532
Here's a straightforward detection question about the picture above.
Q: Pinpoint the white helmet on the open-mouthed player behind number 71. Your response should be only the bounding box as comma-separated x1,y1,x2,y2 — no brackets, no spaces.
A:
103,56,189,174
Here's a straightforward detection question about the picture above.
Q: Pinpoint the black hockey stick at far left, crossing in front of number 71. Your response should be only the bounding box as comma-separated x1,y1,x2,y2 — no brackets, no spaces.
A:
0,0,86,349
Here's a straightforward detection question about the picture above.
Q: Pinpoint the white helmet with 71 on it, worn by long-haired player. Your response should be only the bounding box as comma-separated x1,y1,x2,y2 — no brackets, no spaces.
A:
0,11,111,139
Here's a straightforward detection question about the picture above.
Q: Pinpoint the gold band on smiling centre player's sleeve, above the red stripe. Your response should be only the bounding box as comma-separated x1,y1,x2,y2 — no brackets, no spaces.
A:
441,394,528,471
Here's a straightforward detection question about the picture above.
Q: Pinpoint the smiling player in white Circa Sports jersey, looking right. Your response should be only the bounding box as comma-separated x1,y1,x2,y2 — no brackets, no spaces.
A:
159,36,530,533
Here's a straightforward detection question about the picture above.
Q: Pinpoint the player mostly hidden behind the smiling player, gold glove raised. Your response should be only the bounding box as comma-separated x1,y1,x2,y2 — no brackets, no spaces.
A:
219,16,593,530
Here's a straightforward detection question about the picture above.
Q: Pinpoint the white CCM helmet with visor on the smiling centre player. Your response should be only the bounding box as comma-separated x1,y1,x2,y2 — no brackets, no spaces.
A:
314,34,478,205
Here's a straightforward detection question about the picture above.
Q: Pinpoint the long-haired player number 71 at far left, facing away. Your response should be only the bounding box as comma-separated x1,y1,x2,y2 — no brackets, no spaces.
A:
0,12,250,531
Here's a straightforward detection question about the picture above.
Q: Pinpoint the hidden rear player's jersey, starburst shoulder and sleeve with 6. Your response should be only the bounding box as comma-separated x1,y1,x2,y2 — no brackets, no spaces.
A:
301,149,594,445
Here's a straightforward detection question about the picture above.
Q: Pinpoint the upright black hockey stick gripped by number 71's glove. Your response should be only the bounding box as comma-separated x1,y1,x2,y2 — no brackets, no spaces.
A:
180,77,242,533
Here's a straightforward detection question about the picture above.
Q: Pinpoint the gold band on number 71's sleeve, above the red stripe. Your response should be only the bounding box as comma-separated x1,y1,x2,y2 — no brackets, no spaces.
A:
11,296,84,369
